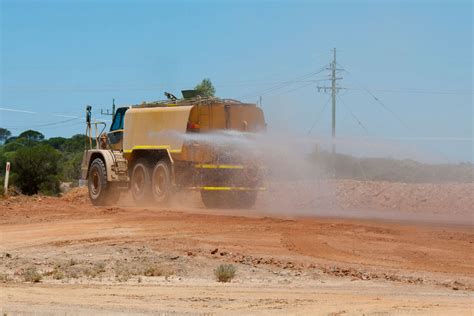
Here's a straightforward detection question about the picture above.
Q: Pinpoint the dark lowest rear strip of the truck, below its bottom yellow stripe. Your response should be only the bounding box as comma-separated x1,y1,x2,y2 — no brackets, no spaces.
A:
201,190,257,209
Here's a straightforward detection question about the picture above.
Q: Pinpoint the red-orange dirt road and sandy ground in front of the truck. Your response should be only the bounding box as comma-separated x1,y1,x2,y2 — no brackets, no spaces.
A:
0,180,474,314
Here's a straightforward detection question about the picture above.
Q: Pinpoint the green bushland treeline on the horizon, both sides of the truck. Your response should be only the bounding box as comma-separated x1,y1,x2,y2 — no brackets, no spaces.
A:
0,128,474,195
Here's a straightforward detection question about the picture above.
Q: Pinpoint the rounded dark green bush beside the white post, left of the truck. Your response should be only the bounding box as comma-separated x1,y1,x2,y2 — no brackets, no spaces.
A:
12,144,61,195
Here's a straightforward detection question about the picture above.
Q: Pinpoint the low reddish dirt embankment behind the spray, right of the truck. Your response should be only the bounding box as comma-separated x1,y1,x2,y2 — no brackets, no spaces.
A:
257,180,474,223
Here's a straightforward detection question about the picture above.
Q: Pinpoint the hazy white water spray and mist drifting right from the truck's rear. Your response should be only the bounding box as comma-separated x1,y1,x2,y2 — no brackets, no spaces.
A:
168,131,474,222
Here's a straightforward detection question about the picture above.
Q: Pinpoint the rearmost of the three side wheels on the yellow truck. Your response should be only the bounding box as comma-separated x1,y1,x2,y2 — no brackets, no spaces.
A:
151,160,172,204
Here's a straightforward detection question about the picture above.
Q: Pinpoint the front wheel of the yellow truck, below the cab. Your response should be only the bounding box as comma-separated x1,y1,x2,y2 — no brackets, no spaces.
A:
87,158,120,206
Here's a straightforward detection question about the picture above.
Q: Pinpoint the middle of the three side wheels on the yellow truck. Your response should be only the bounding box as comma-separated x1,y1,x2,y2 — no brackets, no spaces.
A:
130,159,151,204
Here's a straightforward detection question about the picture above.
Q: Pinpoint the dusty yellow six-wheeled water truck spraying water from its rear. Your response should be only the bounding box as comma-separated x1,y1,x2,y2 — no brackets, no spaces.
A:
81,91,266,208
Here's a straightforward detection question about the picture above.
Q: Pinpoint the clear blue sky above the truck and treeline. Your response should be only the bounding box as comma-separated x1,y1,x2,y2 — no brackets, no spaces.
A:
0,0,474,162
